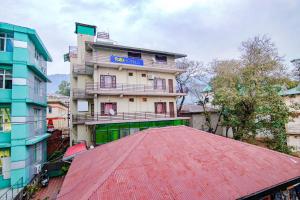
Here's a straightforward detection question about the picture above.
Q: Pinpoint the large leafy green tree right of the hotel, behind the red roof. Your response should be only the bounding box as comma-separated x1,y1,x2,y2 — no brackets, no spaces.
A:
212,36,289,152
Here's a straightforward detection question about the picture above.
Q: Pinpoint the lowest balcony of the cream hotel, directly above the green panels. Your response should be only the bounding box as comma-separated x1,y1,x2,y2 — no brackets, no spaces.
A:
72,112,187,125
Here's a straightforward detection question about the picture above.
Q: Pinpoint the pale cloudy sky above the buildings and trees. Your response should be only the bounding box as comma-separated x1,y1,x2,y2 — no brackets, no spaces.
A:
0,0,300,74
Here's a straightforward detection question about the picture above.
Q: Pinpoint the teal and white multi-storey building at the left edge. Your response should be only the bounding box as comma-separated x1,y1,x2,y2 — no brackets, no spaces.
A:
0,22,52,189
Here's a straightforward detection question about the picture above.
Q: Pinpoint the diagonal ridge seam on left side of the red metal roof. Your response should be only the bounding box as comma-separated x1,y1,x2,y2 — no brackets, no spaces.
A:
83,133,147,199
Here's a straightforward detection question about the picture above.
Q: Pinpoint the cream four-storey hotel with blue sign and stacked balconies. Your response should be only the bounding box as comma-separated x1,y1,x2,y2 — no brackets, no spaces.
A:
65,23,186,145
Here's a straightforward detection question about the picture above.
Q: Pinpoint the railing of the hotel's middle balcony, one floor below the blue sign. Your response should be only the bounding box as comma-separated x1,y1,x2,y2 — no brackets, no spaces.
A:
85,82,177,94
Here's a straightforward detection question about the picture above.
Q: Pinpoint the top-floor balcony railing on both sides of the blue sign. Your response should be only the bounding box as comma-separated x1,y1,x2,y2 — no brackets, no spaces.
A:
85,52,184,70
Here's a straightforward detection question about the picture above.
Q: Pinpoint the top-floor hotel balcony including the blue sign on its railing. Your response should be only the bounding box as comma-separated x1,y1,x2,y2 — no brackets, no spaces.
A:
85,53,186,73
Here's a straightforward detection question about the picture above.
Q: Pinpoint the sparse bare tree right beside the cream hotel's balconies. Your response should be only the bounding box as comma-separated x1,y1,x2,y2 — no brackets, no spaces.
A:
176,59,203,113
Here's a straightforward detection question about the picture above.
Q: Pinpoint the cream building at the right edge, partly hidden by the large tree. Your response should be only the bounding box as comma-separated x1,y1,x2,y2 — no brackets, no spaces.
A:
280,85,300,152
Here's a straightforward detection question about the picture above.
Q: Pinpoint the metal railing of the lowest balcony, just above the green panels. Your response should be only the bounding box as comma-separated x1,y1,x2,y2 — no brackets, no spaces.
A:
72,112,175,123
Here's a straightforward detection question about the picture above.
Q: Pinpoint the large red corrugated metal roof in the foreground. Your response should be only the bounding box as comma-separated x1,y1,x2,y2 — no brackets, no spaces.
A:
58,126,300,200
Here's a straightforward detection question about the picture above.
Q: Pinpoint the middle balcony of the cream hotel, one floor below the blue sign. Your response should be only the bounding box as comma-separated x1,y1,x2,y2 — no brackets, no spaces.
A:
85,82,186,96
